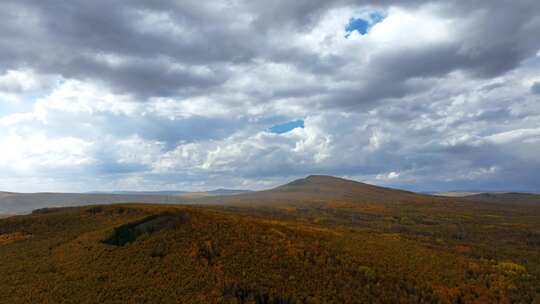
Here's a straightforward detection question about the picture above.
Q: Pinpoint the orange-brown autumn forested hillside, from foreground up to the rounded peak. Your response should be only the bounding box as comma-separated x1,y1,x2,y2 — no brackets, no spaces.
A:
0,176,540,304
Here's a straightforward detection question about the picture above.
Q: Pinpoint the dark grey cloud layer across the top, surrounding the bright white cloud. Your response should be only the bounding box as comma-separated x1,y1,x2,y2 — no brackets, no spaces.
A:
0,0,540,103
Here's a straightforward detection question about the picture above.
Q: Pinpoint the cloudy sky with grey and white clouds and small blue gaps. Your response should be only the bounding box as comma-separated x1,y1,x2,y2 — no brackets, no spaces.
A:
0,0,540,192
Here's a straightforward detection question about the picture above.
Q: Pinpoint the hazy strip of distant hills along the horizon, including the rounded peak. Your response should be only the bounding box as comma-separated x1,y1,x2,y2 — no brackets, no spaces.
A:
0,175,540,214
